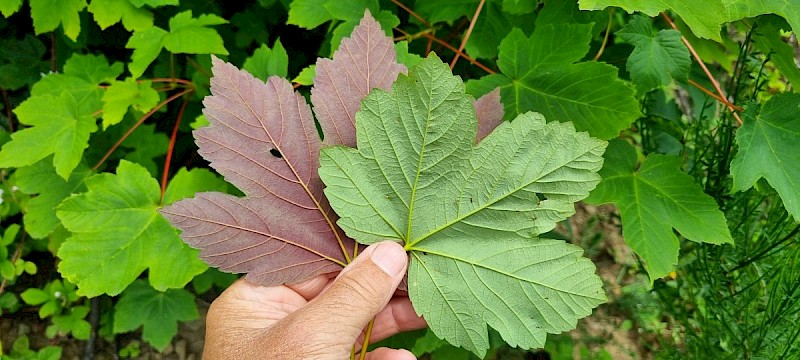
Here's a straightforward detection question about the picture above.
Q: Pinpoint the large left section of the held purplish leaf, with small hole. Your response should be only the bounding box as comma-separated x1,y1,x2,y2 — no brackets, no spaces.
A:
161,58,355,286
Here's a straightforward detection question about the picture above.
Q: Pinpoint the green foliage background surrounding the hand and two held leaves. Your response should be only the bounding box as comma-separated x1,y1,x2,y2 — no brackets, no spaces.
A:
0,0,800,358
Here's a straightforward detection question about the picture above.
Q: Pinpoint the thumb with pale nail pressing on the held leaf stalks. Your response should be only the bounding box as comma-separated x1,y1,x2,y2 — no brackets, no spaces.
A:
296,241,408,346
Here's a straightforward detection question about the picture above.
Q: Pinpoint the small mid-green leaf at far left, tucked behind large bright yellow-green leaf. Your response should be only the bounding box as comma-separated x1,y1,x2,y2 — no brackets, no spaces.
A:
16,159,91,239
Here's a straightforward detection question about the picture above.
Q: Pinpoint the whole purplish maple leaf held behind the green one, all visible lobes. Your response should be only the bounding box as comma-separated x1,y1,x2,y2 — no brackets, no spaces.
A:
161,11,503,285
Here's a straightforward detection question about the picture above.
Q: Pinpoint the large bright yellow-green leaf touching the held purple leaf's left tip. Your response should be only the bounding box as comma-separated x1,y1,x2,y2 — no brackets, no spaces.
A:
56,160,206,297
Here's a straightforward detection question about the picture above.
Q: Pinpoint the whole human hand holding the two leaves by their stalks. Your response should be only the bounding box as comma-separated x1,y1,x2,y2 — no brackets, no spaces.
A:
203,241,427,360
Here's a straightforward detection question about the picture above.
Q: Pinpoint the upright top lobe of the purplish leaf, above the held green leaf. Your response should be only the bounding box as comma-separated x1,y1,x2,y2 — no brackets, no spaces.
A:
311,10,406,147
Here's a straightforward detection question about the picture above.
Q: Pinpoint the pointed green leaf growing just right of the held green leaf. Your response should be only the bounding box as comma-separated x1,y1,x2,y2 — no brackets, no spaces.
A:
586,140,733,282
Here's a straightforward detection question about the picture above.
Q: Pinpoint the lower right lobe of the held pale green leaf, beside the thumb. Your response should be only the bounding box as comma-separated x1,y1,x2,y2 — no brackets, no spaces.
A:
408,237,606,357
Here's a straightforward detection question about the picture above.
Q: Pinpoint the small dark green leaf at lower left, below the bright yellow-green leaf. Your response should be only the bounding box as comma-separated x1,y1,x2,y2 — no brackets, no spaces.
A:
114,280,200,351
